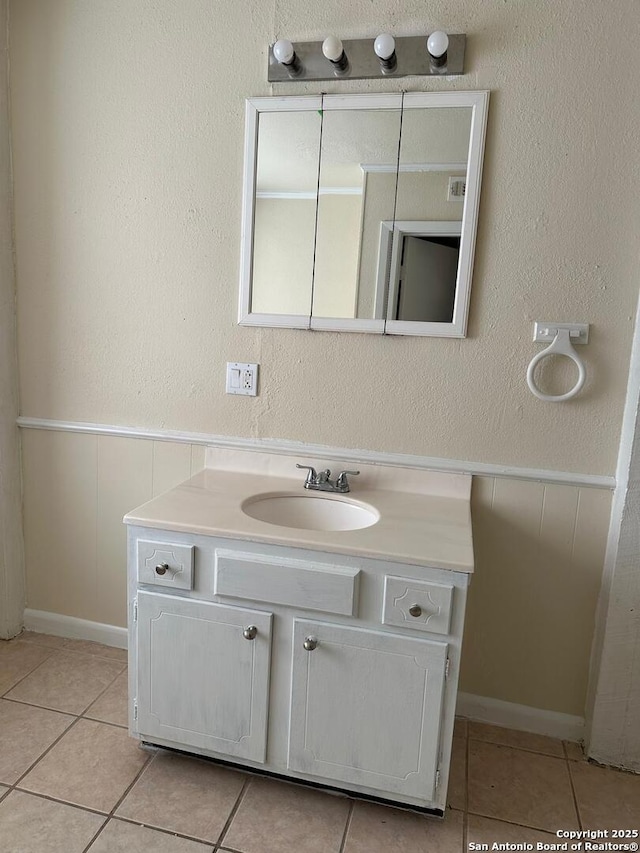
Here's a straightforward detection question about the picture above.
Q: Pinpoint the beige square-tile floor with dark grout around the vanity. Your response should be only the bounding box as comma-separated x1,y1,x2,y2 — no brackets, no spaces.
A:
0,633,640,853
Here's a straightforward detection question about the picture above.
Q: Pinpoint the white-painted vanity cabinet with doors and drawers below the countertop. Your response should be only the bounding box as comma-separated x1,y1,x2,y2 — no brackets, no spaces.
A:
128,525,468,814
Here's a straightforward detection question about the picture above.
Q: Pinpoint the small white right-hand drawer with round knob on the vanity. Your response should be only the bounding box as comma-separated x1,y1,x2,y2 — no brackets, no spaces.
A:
382,575,453,634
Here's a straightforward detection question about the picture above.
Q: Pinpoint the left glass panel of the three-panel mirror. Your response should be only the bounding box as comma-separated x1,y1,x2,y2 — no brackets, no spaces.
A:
251,110,322,317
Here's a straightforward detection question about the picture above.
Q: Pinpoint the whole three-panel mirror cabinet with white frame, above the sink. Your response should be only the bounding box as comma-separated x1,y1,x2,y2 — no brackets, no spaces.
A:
239,92,488,337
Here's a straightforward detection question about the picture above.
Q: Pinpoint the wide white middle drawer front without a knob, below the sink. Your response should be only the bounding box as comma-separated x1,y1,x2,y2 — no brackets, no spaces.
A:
214,549,360,616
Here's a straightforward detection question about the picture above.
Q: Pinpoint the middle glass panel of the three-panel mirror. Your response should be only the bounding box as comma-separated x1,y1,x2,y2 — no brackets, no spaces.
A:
312,105,401,319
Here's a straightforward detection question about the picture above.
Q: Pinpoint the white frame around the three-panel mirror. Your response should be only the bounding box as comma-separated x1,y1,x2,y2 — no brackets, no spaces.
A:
238,91,489,338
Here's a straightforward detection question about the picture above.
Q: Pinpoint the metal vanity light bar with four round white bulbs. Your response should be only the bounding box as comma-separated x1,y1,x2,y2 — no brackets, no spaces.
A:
267,30,467,83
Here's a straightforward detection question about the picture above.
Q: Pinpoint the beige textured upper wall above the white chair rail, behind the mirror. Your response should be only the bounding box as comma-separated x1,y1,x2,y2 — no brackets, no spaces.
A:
10,0,640,474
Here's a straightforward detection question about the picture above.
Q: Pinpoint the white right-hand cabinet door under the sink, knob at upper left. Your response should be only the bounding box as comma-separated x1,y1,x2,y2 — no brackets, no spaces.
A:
288,619,447,800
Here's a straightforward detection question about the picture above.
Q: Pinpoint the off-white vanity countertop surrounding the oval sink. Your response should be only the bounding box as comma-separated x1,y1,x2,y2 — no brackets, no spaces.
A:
124,457,473,573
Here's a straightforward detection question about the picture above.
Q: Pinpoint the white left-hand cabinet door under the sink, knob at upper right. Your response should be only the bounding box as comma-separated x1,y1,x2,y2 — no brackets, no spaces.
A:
137,592,271,762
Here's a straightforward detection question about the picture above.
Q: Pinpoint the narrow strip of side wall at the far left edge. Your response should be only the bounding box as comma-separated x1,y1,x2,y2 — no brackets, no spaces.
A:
0,0,24,639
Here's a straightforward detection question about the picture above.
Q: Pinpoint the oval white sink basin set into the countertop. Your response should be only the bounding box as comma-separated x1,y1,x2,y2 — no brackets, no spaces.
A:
242,493,380,530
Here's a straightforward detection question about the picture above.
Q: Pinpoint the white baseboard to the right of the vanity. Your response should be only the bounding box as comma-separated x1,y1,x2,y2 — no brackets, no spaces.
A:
456,693,584,741
